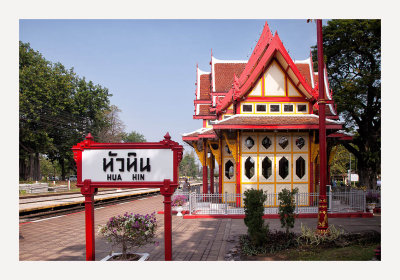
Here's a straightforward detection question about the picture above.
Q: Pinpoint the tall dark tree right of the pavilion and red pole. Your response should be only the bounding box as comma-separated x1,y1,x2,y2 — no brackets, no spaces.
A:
313,20,381,189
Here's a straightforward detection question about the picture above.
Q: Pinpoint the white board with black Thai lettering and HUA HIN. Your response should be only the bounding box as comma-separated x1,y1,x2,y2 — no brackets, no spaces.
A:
82,149,174,182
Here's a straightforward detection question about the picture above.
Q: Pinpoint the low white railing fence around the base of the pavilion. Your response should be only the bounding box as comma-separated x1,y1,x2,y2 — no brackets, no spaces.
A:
172,190,372,215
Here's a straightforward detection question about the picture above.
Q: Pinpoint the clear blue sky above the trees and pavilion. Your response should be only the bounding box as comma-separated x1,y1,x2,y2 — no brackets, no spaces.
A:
19,19,324,151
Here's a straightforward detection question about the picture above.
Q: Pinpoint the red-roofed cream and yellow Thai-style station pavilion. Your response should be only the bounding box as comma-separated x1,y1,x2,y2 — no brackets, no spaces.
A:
182,23,348,201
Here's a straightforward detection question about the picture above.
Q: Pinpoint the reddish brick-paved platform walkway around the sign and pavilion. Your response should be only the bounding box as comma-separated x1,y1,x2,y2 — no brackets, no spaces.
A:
19,196,381,261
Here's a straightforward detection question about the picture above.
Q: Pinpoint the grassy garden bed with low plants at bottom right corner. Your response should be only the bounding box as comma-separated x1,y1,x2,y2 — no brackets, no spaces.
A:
239,226,381,261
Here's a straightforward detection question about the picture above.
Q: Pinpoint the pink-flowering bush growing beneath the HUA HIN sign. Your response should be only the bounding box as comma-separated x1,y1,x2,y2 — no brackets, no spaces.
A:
98,212,157,259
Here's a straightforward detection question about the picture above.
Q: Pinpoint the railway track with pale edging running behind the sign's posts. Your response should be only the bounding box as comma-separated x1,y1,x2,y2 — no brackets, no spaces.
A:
19,189,160,223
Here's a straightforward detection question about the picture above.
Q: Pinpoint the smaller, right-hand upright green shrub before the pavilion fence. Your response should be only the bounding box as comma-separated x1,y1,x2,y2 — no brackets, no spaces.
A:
278,188,298,234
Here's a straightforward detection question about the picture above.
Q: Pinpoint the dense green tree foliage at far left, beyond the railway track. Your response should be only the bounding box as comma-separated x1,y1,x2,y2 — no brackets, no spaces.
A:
19,42,111,179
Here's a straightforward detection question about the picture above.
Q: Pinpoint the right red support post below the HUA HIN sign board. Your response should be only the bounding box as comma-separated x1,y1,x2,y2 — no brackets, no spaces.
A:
161,180,173,261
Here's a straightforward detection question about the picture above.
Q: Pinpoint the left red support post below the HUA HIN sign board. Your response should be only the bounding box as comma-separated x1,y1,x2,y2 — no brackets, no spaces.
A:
81,180,95,261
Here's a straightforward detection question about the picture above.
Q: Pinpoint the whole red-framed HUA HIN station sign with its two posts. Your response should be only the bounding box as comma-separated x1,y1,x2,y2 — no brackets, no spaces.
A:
72,133,183,261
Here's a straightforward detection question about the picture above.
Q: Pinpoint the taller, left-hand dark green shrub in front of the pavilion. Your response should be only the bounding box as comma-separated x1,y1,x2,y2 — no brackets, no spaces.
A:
243,189,269,246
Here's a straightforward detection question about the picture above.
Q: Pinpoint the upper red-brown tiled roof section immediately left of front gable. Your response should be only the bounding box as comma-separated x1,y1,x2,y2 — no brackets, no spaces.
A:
214,63,246,92
